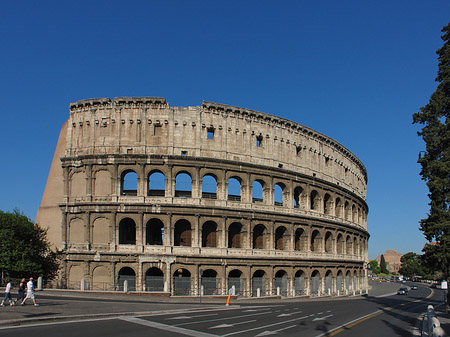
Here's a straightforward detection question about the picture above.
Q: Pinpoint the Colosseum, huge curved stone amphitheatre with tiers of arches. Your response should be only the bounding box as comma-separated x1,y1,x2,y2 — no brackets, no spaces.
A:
36,97,369,297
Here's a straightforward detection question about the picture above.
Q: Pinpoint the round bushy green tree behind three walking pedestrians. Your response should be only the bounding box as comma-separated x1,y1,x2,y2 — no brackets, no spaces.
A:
0,210,59,281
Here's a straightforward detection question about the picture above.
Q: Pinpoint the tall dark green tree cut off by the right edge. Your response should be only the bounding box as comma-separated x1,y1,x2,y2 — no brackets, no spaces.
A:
413,23,450,278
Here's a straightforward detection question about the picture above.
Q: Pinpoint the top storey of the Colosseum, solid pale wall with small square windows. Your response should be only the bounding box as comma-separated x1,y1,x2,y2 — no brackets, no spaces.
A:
65,97,367,199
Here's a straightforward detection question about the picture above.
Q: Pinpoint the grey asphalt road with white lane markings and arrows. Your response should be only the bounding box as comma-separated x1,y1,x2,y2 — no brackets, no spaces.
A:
0,285,443,337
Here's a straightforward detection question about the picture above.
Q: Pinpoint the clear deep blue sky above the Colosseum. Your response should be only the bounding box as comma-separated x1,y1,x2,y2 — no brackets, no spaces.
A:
0,0,450,258
